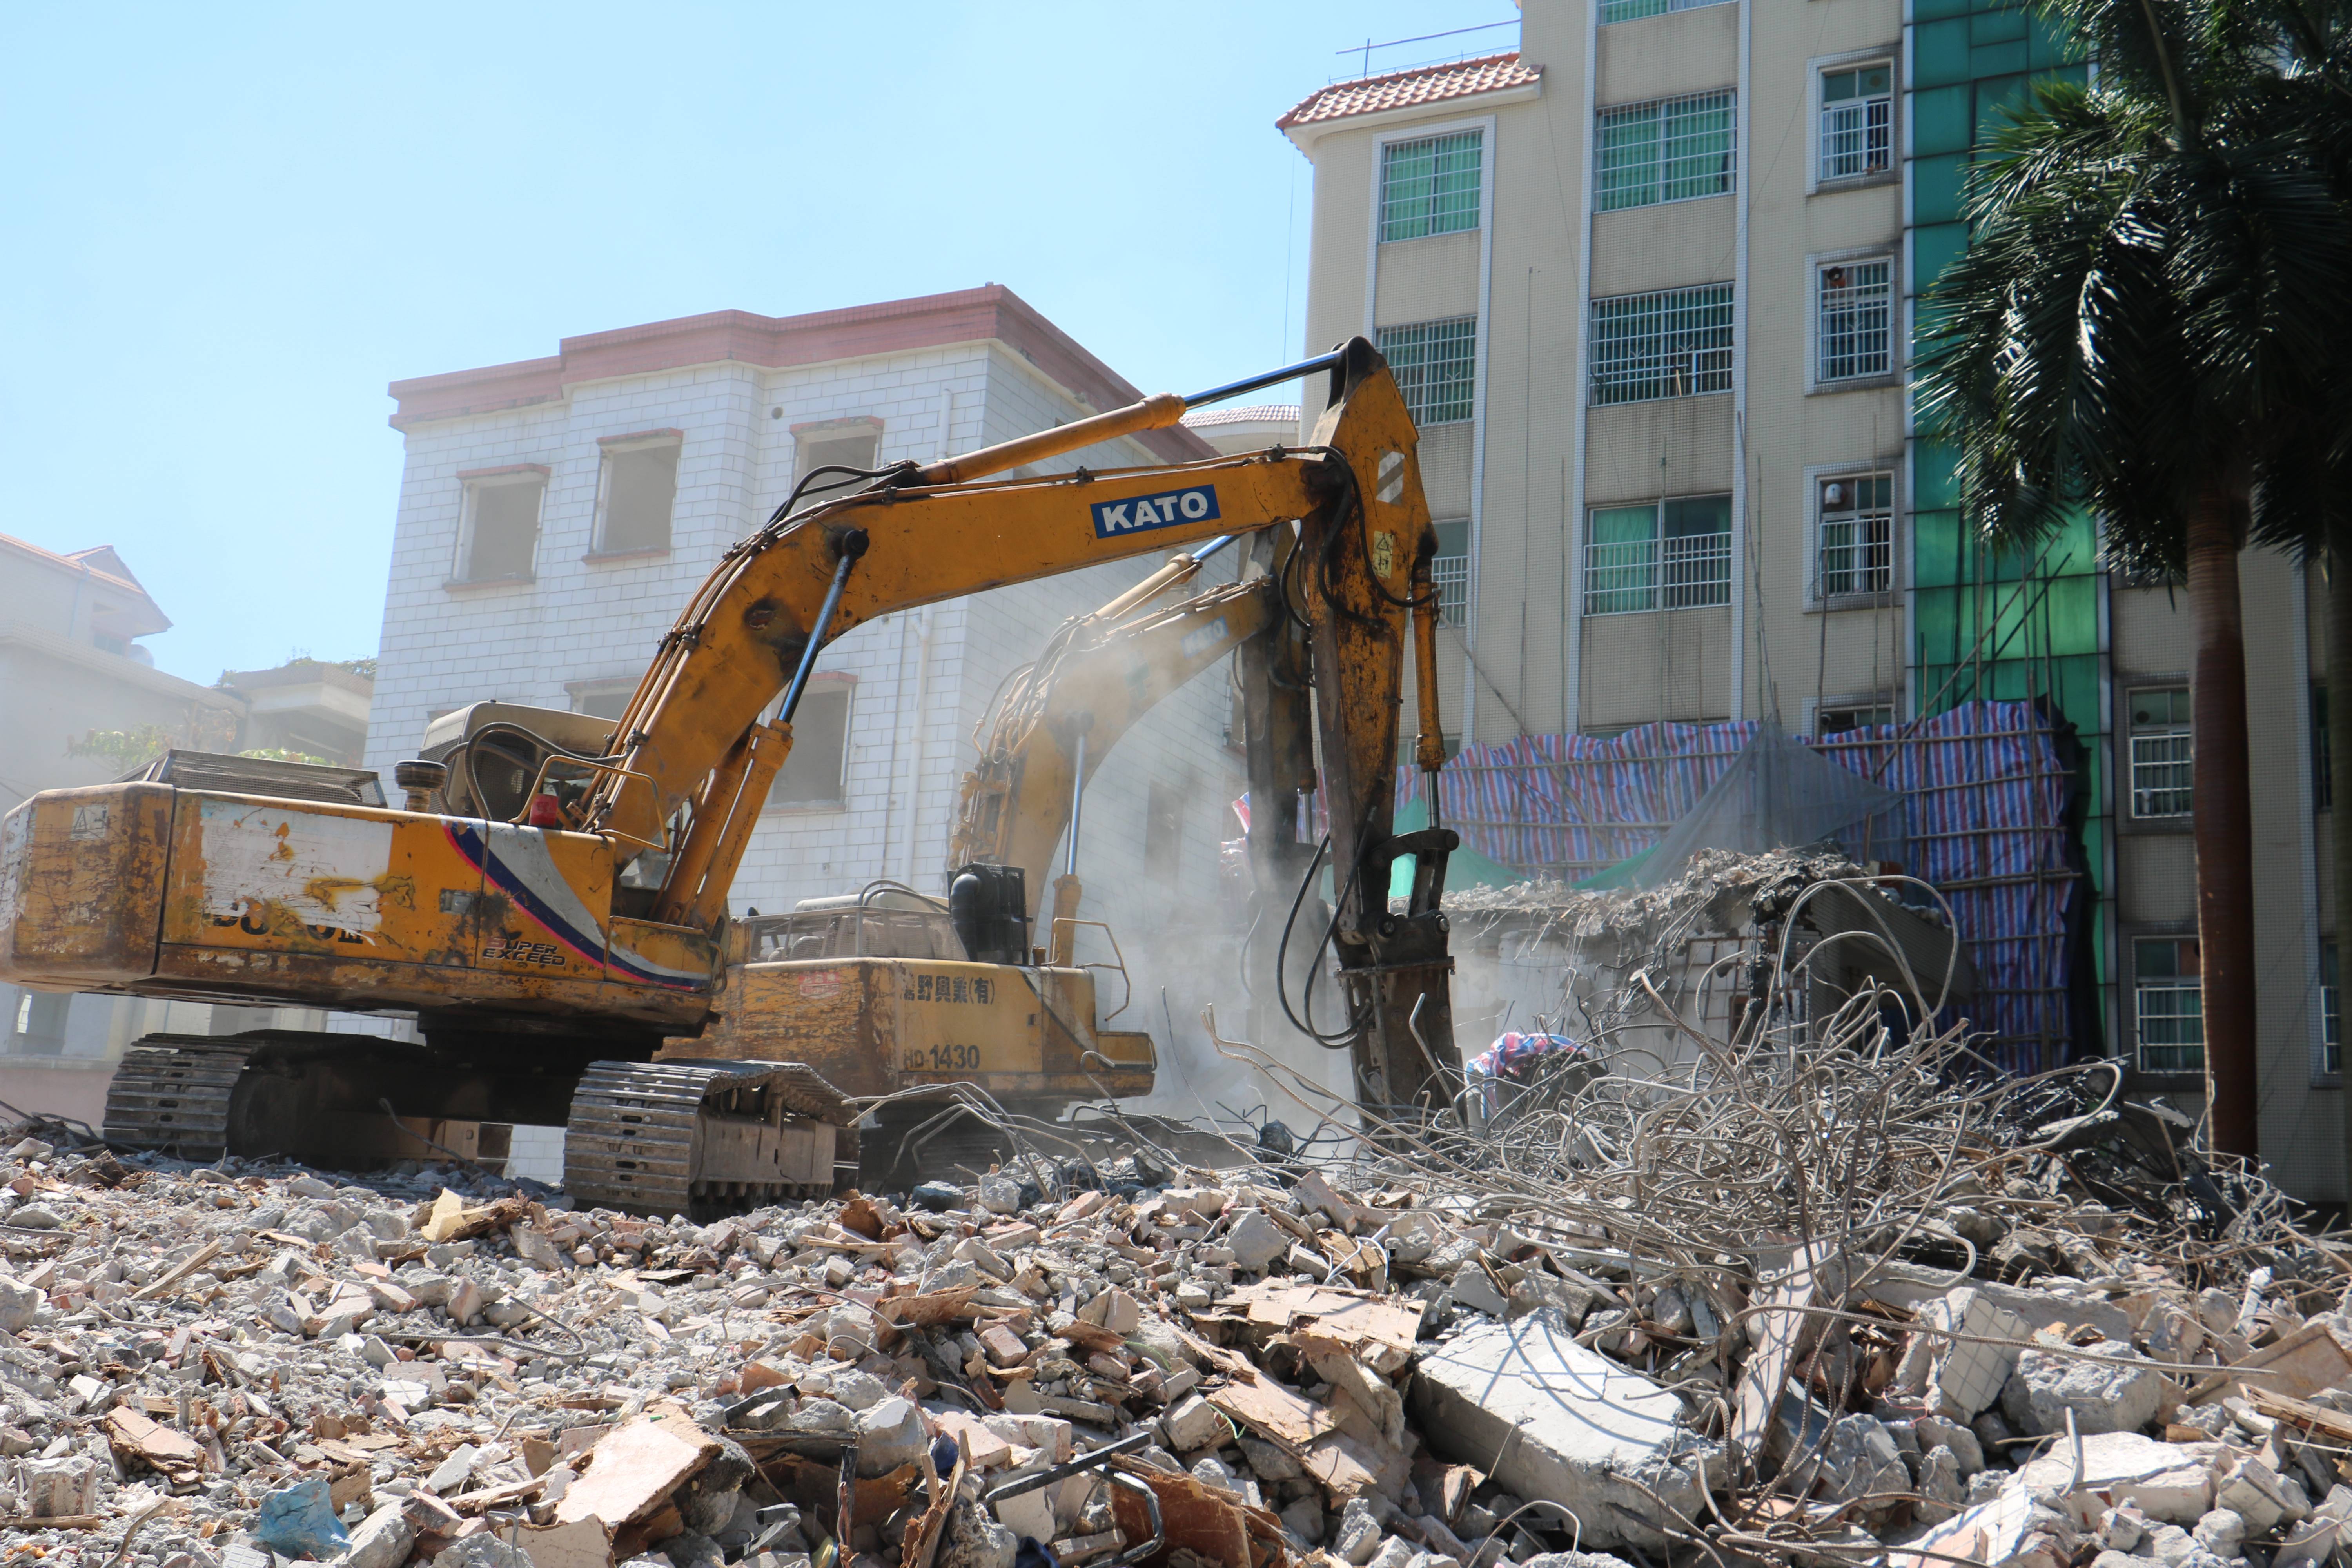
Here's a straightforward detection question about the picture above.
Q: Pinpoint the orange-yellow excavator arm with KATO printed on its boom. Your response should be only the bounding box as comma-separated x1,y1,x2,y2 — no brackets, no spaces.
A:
579,339,1454,1105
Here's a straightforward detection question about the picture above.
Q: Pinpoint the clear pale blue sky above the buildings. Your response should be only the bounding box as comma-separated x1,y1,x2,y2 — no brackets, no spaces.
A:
0,0,1517,682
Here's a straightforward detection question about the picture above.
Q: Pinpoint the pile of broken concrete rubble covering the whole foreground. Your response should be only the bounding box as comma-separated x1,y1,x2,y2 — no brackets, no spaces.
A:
0,1029,2352,1568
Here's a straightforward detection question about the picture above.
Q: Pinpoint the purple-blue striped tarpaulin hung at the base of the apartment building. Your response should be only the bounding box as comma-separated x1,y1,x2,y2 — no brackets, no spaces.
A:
1397,703,2074,1072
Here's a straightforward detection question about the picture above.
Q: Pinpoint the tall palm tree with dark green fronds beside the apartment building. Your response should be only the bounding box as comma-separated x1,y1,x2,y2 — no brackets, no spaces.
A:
1922,0,2352,1154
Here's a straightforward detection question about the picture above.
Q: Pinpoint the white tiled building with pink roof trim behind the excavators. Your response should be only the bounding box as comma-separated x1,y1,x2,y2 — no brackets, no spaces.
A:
367,285,1242,964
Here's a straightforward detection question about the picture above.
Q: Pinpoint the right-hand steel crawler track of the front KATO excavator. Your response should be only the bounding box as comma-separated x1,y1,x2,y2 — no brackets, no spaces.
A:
564,1063,856,1218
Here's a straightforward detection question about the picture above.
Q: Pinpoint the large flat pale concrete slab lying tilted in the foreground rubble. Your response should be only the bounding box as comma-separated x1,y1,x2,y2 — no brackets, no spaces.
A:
1411,1314,1724,1552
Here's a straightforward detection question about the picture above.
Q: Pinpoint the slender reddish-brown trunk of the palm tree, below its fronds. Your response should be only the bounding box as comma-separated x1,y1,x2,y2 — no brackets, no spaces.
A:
2187,491,2260,1157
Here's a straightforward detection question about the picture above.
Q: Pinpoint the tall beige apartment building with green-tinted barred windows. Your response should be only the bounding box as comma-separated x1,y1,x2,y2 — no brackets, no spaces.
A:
1277,0,2345,1199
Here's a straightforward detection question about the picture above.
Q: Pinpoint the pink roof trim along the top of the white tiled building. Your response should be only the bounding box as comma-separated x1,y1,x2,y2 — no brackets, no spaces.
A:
388,282,1216,463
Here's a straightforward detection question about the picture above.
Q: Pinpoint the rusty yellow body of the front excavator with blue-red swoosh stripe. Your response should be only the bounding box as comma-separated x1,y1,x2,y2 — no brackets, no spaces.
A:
0,783,717,1032
